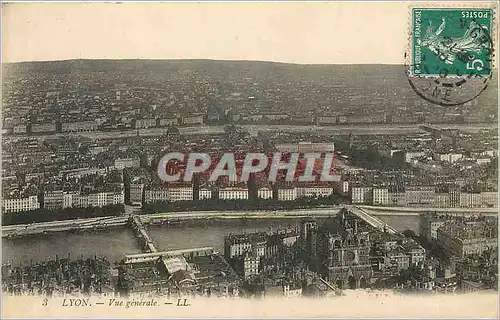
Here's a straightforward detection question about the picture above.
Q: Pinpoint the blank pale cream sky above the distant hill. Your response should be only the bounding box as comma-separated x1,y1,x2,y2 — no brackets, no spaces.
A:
2,2,496,64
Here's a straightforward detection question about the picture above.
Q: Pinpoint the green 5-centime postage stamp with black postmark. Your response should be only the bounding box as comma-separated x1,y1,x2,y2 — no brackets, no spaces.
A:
410,8,494,77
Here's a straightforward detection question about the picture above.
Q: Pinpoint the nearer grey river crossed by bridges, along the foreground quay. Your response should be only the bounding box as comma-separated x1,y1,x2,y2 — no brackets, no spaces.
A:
2,215,420,265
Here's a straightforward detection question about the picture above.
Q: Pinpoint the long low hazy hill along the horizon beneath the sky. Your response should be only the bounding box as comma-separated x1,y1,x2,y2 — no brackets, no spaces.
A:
3,60,498,114
